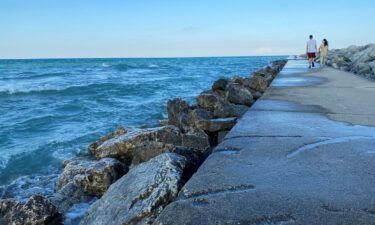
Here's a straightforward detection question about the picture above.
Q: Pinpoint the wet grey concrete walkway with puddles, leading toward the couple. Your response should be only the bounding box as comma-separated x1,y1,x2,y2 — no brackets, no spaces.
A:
159,60,375,225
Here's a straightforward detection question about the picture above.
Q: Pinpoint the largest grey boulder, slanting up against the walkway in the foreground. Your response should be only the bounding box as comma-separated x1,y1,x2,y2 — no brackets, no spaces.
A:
80,153,186,225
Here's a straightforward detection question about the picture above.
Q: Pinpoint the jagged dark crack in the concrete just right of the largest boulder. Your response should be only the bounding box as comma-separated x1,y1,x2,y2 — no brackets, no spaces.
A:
183,184,255,200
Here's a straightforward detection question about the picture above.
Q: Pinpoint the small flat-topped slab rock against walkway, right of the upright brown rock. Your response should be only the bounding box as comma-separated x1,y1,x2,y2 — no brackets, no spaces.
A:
197,118,237,133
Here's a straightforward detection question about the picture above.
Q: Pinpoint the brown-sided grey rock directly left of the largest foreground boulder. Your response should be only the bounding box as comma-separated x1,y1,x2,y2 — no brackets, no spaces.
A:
56,158,126,197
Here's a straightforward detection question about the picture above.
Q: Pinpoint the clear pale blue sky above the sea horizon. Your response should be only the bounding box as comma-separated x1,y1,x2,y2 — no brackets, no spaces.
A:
0,0,375,59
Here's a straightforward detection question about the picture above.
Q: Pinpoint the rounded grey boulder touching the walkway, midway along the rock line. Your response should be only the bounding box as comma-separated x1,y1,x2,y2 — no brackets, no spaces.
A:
226,83,254,106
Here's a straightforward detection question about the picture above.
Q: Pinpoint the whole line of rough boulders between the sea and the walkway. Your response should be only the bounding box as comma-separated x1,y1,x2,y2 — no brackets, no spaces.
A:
0,60,287,225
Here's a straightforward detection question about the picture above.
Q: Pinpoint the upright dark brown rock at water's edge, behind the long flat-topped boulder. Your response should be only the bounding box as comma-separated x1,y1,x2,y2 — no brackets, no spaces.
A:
167,98,190,130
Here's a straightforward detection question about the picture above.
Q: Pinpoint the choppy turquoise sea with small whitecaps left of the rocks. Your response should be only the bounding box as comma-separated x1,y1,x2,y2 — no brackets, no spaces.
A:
0,57,285,199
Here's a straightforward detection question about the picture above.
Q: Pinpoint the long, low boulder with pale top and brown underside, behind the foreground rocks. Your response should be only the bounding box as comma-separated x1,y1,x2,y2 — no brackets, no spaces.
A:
91,126,208,167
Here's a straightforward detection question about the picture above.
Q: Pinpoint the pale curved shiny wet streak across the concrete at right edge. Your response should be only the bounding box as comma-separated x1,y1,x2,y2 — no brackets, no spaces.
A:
286,136,375,158
